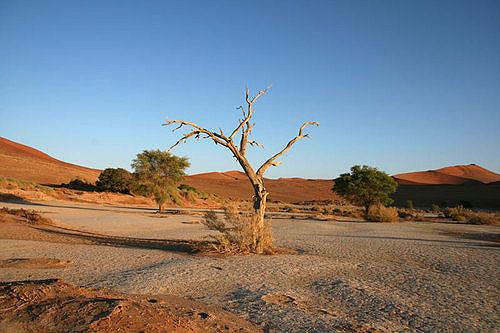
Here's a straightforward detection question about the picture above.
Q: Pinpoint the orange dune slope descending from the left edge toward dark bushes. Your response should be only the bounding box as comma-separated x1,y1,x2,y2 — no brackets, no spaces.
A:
0,137,101,184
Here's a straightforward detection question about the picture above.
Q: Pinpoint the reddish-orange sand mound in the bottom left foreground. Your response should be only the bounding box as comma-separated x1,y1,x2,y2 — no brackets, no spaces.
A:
0,279,262,333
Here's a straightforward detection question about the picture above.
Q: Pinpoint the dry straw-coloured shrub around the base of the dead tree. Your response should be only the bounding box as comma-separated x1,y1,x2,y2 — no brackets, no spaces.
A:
202,205,275,254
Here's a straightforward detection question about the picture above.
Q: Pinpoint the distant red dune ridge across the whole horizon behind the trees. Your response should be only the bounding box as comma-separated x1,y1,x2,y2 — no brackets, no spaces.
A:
0,137,500,207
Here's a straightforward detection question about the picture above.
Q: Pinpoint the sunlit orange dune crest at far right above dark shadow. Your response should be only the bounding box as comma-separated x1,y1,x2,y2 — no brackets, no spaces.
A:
393,164,500,185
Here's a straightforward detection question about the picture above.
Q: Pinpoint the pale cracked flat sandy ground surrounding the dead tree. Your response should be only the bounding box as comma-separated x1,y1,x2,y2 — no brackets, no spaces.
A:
0,198,500,332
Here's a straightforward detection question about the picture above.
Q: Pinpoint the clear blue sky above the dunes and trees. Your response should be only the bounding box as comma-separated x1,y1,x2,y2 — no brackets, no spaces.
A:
0,0,500,178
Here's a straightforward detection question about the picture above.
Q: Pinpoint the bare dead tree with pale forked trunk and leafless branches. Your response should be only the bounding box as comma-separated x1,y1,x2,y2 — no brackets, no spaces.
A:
163,86,319,253
